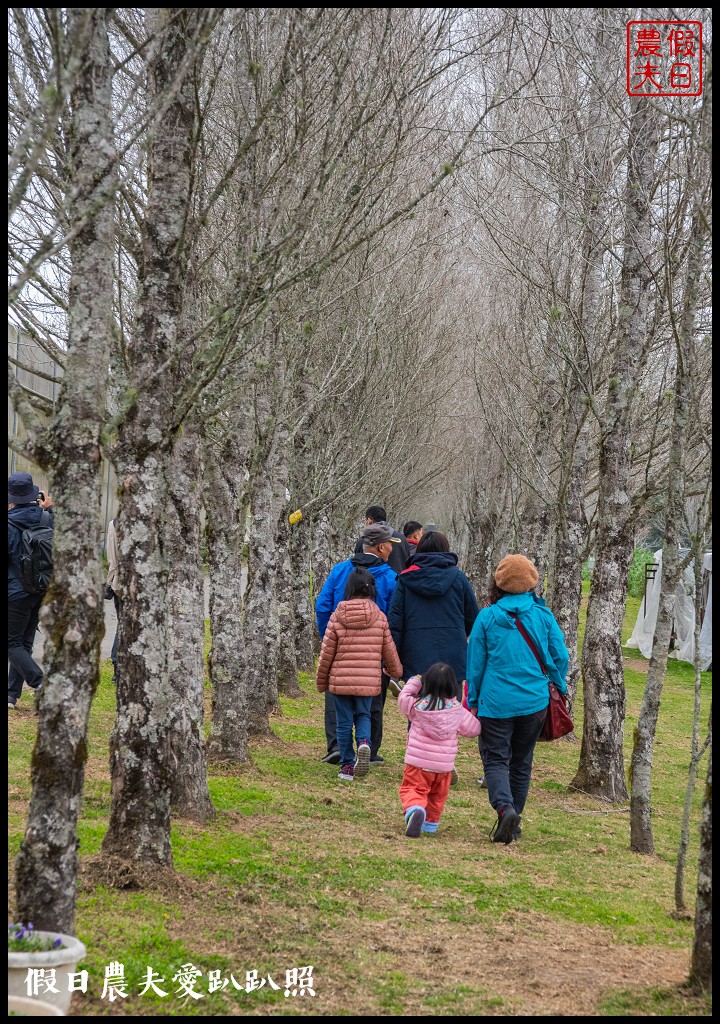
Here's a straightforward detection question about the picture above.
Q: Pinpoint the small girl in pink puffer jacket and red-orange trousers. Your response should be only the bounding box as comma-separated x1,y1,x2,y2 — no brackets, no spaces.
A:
397,662,480,839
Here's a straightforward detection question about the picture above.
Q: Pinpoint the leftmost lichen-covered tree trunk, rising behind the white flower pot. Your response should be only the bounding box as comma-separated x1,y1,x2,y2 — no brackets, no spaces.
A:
16,8,115,935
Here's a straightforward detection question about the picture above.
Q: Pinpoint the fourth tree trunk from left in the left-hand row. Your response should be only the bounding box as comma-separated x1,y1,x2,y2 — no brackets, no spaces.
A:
205,438,249,765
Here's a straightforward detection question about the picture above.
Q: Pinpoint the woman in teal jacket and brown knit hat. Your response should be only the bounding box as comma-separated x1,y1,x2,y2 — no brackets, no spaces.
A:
467,555,569,844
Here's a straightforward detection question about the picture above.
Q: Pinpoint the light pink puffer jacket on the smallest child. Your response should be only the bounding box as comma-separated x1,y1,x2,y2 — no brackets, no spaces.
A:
397,676,480,771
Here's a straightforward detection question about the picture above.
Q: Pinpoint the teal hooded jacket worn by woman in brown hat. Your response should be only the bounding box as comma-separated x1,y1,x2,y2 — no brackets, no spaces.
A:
467,591,569,718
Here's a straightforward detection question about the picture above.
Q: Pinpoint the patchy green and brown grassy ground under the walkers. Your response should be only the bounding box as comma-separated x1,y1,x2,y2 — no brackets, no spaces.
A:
9,602,711,1016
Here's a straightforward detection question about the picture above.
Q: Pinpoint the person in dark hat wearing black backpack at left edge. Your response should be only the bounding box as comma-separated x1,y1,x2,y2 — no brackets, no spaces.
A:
7,473,53,710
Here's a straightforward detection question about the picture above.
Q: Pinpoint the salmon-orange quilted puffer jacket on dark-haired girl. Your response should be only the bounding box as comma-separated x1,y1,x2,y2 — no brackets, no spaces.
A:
315,598,403,697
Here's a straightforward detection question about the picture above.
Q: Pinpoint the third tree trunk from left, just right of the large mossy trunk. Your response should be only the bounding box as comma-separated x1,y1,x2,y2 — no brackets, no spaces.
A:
165,421,215,822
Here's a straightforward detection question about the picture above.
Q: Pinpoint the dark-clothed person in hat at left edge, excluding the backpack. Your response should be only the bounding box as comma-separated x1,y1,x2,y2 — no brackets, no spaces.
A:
7,473,52,709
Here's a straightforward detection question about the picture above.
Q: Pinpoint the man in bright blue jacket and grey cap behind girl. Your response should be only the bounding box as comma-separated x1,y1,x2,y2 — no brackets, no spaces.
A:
315,523,397,765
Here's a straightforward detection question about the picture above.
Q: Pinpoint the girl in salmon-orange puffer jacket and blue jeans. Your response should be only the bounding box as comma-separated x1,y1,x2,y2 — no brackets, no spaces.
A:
315,568,403,782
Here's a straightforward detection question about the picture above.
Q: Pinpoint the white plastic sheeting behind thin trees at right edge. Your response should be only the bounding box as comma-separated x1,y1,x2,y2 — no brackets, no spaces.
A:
625,551,713,672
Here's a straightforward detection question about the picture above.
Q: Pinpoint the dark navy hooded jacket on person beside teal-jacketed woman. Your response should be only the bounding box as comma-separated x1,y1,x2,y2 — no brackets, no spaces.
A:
387,551,478,683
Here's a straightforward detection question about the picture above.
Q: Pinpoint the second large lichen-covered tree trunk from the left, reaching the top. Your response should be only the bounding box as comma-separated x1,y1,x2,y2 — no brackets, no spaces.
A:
102,7,197,866
